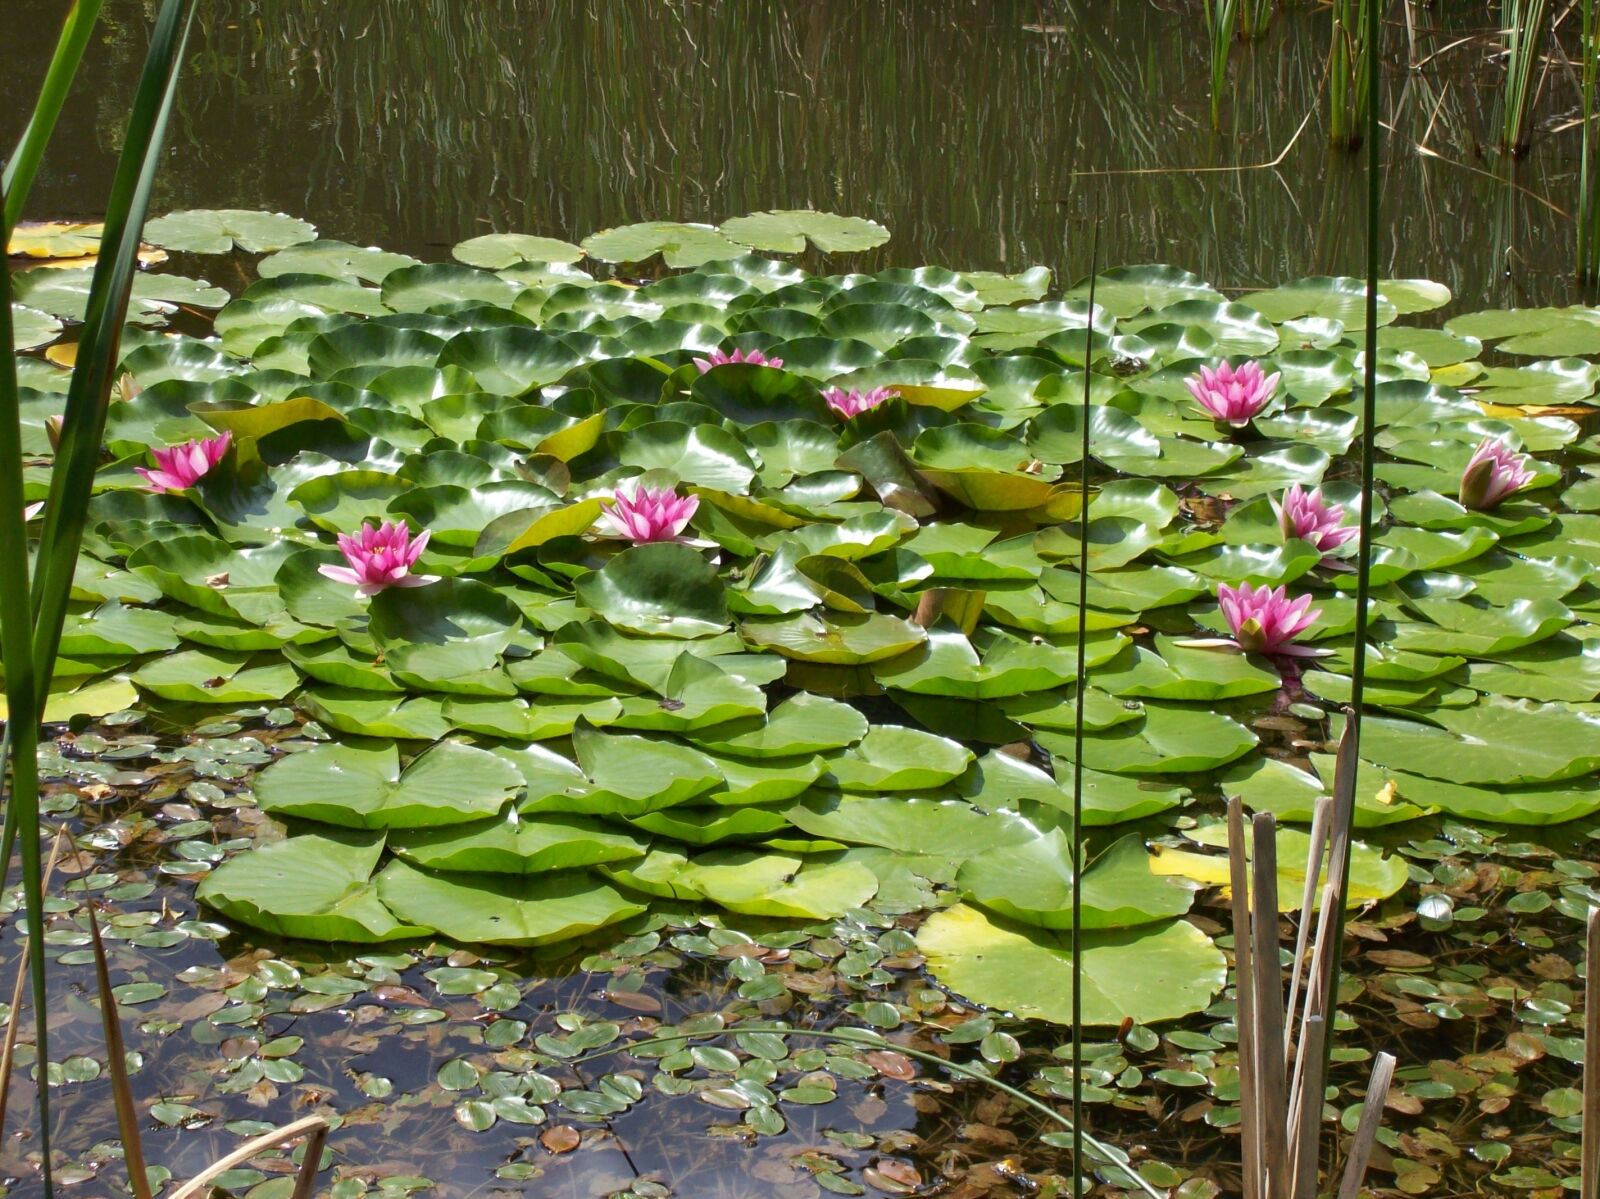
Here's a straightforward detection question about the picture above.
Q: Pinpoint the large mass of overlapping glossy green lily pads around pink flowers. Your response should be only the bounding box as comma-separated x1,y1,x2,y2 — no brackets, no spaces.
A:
18,213,1600,1023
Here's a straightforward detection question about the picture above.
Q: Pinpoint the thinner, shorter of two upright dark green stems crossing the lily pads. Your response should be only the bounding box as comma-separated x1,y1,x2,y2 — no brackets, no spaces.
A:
1072,219,1099,1199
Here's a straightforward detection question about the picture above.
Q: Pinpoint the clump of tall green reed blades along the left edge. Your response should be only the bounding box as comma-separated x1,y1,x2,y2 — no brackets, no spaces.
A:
0,0,194,1196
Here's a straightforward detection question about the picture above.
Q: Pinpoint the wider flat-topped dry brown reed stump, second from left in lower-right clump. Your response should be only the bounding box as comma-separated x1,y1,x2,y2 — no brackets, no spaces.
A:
1250,812,1290,1199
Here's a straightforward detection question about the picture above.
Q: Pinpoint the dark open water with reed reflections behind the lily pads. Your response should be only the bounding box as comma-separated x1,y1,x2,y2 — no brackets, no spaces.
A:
0,0,1579,307
